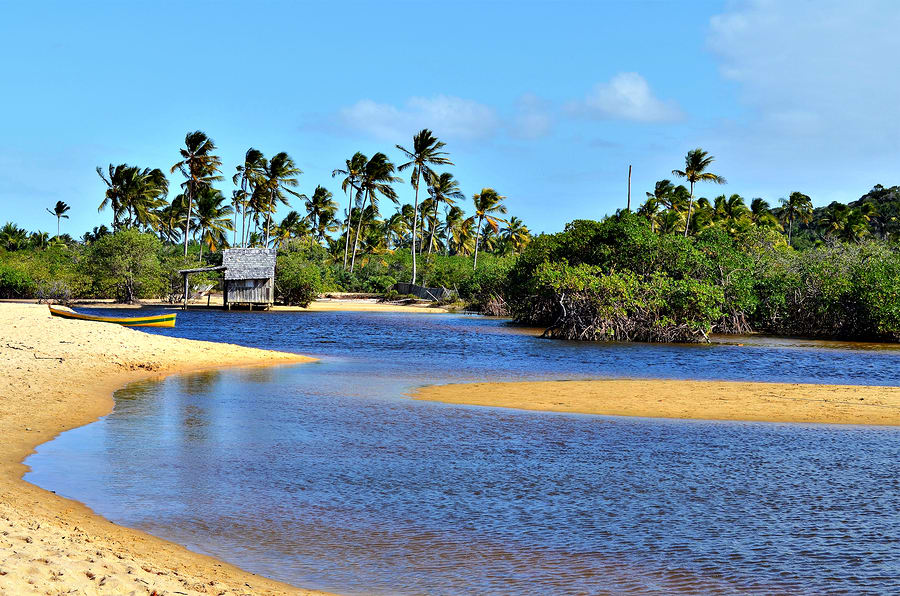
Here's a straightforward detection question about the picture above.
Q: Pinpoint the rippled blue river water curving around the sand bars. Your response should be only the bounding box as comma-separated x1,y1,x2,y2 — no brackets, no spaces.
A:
26,311,900,594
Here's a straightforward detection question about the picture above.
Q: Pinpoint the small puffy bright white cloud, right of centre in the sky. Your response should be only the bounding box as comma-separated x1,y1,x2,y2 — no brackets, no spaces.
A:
568,72,683,122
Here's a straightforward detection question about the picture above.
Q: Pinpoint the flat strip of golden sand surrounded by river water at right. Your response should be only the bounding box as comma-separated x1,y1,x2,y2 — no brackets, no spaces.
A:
414,379,900,426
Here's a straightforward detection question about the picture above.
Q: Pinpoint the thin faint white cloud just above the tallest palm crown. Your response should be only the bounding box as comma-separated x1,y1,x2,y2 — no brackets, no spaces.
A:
340,95,500,142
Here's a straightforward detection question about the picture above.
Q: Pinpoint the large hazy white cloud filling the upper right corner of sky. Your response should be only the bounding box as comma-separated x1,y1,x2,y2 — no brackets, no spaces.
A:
704,0,900,204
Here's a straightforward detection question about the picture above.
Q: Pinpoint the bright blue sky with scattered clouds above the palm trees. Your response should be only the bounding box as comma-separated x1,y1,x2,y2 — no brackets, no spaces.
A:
0,0,900,236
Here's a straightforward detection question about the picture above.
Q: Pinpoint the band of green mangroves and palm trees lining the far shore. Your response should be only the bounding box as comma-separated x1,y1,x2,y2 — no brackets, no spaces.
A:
0,141,900,341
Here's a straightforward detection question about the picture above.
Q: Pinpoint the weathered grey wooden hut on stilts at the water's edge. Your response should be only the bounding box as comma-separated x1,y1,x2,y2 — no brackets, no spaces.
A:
222,248,275,309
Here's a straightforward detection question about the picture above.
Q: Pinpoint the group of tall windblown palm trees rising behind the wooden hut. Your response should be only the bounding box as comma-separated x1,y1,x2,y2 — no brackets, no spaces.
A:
84,129,531,276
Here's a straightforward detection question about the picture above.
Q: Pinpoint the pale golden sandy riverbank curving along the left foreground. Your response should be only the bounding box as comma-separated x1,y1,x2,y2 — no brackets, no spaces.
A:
0,303,324,595
